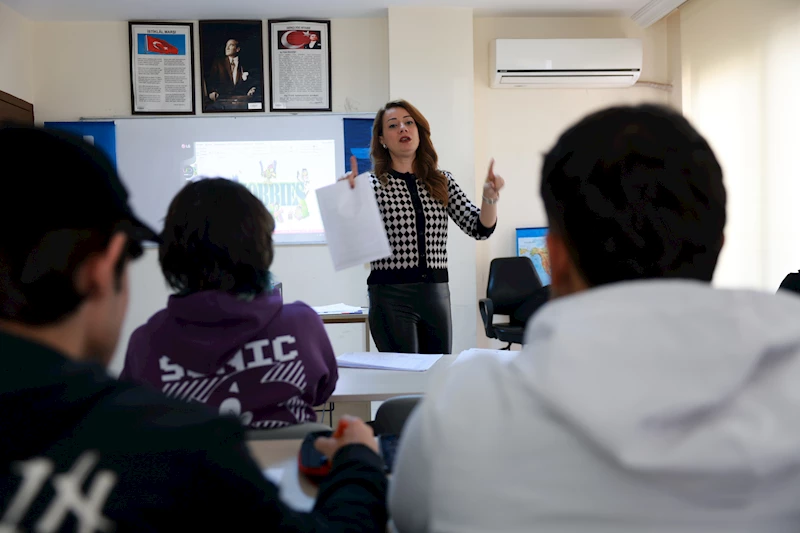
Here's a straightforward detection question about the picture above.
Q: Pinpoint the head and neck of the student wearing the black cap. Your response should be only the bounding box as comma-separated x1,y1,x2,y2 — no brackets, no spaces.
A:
0,125,157,363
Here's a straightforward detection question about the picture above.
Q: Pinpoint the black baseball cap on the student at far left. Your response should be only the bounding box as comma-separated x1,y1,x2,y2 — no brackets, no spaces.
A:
0,123,160,249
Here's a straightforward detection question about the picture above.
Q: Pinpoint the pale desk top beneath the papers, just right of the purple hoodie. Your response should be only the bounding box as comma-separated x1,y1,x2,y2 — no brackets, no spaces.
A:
330,354,457,402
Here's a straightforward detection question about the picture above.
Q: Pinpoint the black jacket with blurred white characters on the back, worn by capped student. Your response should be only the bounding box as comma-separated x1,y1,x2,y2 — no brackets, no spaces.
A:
0,333,387,532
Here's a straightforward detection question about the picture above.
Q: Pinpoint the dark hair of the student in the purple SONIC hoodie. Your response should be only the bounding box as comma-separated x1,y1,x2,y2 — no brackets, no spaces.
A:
159,178,275,294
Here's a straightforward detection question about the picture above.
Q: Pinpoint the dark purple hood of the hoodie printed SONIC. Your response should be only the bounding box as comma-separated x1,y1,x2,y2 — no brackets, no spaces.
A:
143,291,283,374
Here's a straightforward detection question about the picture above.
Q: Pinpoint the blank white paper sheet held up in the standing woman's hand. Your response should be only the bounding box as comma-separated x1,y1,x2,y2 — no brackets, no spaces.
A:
317,174,392,272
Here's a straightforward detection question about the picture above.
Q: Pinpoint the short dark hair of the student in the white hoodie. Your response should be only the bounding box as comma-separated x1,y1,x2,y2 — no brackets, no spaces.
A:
541,105,726,286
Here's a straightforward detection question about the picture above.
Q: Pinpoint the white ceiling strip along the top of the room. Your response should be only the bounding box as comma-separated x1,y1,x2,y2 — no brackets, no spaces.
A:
0,0,650,21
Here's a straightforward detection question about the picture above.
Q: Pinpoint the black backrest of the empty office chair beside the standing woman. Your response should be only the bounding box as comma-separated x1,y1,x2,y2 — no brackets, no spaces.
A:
486,257,542,315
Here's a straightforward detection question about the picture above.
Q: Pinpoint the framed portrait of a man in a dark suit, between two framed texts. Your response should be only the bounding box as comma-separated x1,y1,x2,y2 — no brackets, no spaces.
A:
199,20,265,113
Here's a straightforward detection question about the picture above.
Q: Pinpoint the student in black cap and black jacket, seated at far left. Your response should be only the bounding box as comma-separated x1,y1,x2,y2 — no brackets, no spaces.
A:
0,122,387,532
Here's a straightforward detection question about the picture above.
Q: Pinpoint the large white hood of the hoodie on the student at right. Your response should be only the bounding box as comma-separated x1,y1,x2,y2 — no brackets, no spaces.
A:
510,281,800,506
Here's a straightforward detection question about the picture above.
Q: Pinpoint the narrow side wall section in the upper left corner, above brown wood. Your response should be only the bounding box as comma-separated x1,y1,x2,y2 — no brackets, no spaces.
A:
0,3,38,103
